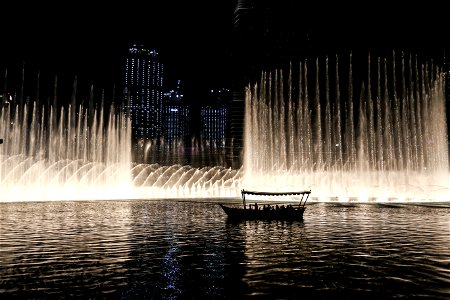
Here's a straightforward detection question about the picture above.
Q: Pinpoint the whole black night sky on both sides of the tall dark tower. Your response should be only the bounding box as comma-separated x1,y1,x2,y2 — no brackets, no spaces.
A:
0,0,450,103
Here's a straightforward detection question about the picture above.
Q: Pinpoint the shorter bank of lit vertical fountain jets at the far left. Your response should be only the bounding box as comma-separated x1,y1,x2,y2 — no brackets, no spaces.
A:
0,98,132,201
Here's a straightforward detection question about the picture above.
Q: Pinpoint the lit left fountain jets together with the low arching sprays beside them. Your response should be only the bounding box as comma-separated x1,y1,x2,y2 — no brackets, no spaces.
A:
0,74,241,202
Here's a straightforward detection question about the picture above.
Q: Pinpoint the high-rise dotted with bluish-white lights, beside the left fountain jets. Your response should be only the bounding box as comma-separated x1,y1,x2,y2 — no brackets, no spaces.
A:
124,44,164,162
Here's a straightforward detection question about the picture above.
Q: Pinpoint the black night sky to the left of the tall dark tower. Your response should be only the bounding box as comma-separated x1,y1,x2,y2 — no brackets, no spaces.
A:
0,0,234,101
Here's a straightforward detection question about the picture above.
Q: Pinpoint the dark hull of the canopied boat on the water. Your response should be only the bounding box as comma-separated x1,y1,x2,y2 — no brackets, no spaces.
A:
219,204,305,221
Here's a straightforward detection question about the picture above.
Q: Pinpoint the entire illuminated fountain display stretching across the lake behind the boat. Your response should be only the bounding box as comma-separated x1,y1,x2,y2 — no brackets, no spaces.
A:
0,54,450,202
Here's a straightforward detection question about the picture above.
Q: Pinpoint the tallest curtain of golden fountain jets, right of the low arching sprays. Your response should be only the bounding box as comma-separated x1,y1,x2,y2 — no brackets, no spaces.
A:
243,53,450,201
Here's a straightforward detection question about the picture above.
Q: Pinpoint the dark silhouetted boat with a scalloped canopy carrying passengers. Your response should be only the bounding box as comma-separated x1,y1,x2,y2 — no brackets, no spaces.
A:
219,189,311,221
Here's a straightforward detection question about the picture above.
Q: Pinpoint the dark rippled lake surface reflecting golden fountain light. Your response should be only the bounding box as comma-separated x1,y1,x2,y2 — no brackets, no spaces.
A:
0,199,450,299
